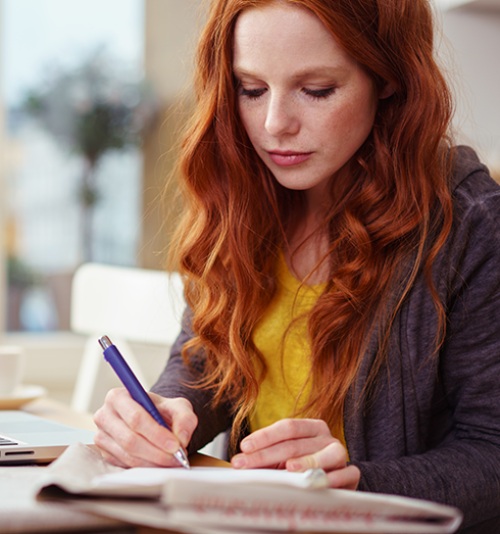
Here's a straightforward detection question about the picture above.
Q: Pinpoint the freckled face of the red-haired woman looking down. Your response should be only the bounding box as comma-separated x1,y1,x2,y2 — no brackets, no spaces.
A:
233,2,378,203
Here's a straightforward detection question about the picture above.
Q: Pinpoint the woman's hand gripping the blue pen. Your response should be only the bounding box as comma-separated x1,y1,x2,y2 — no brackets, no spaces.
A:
94,388,198,467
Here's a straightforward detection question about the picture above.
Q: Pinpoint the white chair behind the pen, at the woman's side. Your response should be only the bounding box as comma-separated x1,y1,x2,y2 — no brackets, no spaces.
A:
71,263,185,412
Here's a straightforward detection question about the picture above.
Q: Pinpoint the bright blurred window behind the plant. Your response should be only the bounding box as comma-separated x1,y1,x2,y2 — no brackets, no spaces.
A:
0,0,146,331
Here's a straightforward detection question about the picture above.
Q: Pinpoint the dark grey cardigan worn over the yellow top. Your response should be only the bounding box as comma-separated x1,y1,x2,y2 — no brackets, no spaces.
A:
152,147,500,534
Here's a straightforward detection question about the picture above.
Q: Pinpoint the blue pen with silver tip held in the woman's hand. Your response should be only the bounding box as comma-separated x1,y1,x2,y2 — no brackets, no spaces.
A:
99,336,191,469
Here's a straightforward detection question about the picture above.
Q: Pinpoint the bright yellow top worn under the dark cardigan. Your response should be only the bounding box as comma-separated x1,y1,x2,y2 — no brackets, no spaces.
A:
249,254,345,454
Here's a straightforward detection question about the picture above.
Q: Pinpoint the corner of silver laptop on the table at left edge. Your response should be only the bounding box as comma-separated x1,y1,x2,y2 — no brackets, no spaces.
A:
0,410,94,465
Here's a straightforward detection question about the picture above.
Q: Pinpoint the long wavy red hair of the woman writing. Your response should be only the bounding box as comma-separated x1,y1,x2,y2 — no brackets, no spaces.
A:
173,0,452,450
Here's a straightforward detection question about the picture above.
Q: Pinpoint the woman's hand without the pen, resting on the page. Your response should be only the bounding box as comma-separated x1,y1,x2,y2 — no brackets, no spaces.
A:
231,419,361,490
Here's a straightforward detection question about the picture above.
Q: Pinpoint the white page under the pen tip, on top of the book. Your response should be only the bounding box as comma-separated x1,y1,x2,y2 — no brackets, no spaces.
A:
92,467,328,488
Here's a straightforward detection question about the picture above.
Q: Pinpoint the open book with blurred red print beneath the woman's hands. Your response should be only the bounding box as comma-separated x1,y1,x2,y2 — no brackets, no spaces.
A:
39,444,462,534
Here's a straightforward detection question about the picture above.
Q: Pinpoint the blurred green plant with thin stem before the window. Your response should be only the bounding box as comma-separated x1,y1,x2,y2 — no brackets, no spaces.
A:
23,51,156,261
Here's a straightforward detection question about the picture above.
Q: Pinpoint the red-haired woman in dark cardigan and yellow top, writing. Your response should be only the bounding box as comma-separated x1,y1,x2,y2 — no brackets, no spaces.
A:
95,0,500,532
